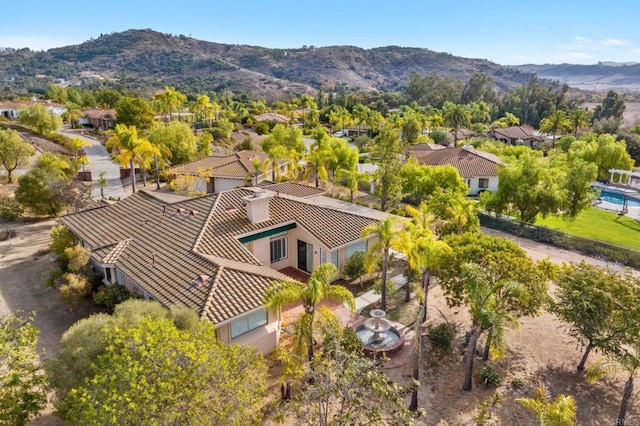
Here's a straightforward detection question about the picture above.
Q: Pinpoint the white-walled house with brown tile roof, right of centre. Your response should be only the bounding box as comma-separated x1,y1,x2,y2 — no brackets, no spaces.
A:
409,144,502,195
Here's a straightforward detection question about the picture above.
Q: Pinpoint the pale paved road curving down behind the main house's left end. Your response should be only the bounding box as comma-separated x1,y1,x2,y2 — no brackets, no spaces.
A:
60,131,127,200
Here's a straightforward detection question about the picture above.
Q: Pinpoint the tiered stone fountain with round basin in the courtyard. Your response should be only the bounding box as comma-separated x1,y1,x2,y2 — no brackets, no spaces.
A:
356,309,404,355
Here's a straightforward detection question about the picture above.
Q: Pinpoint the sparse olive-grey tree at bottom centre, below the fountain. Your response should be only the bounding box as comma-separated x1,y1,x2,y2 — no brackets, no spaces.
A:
278,349,413,426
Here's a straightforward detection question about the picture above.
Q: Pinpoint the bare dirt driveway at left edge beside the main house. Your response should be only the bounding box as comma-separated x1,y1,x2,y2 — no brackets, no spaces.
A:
0,220,92,359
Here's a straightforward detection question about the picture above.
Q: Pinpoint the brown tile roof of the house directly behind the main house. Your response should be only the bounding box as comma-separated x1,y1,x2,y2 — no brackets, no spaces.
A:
167,151,284,179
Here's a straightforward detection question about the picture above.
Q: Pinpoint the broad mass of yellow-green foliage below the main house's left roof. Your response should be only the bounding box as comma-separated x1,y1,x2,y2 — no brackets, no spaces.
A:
48,300,266,425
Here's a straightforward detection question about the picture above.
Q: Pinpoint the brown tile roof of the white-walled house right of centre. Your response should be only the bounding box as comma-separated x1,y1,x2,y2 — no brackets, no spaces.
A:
410,147,501,178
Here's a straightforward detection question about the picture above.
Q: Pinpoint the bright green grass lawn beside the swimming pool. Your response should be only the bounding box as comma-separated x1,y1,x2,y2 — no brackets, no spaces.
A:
536,207,640,251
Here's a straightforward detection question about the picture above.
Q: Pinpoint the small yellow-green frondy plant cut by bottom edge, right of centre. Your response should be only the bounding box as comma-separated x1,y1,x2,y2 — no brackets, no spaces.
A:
516,386,576,426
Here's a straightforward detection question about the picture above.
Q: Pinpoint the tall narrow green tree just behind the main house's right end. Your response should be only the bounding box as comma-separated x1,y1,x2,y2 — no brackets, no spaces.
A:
369,128,404,211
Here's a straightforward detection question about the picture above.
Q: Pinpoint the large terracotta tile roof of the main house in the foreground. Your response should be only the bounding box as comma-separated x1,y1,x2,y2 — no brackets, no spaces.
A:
60,189,375,323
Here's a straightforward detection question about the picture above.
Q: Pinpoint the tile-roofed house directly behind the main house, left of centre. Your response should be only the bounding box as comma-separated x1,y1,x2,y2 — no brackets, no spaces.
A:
166,151,288,194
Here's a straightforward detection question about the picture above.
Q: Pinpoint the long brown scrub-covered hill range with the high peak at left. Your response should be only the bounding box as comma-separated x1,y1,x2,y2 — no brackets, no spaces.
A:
0,30,530,98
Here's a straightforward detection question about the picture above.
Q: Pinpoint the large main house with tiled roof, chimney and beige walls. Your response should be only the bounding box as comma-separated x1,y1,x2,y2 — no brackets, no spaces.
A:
60,184,376,353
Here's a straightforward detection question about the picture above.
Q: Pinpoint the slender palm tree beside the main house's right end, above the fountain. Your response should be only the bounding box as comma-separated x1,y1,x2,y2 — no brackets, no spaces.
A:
362,216,400,311
